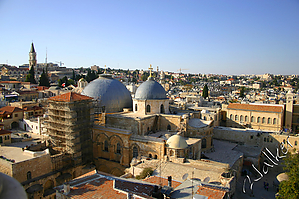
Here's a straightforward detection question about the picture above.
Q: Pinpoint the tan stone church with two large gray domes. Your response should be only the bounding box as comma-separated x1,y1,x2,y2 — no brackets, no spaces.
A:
91,67,213,175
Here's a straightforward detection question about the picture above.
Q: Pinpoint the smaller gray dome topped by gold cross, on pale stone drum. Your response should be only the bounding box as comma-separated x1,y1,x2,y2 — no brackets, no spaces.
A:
135,77,167,100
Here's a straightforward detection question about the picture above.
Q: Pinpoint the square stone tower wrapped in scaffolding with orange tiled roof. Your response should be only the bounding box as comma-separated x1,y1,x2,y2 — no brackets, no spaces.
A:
47,92,93,165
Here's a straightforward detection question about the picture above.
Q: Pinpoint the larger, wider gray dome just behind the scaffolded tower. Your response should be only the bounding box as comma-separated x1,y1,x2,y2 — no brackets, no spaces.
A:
81,74,133,113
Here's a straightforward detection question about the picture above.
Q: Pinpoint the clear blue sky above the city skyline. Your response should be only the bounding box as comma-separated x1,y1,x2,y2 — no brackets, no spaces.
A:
0,0,299,75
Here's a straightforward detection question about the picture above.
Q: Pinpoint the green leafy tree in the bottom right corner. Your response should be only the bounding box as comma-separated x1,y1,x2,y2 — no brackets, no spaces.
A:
279,153,299,199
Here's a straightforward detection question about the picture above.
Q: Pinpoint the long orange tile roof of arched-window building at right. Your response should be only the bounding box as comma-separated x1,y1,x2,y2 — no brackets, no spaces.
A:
227,103,284,113
